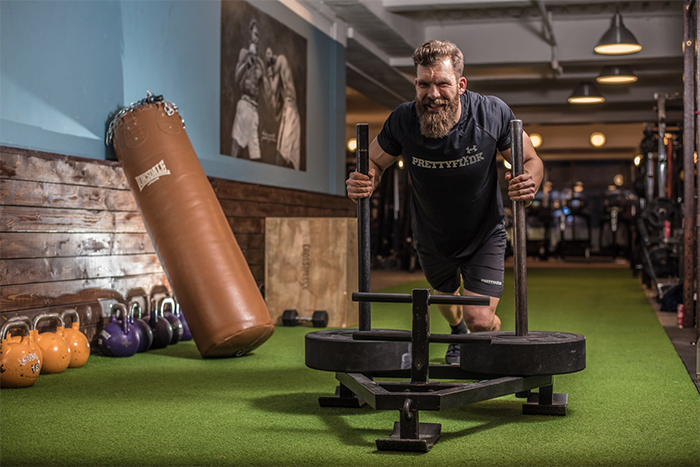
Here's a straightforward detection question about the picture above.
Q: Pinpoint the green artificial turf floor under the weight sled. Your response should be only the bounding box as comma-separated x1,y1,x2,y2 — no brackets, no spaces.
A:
0,269,700,466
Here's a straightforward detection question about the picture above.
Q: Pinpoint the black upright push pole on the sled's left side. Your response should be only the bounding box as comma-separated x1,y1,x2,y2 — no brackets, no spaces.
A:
355,123,372,331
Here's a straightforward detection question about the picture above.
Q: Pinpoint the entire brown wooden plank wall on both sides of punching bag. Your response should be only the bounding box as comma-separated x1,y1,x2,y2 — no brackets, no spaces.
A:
0,146,355,343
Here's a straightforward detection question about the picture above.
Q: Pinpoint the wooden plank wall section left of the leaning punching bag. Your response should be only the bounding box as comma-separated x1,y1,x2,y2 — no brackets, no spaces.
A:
0,147,169,329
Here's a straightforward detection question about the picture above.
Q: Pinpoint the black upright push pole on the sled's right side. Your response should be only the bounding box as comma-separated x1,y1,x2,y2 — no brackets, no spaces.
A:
510,120,528,336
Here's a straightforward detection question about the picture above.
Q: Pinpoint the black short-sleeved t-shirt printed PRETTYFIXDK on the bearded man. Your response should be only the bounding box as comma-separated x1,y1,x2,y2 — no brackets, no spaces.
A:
377,90,515,257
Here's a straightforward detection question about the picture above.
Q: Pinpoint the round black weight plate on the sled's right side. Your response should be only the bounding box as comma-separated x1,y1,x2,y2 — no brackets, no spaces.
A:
460,331,586,376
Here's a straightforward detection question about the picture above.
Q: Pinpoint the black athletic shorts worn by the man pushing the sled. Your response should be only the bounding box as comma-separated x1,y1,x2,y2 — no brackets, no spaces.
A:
417,224,507,298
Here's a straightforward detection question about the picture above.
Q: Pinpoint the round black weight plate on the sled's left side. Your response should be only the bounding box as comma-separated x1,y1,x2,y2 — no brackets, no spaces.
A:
305,329,411,373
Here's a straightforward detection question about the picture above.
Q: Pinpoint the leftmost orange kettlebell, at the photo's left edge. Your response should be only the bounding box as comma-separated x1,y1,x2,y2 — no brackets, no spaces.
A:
0,319,41,388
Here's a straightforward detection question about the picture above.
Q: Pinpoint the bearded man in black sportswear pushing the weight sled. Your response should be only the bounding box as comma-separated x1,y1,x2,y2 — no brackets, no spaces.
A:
346,40,543,364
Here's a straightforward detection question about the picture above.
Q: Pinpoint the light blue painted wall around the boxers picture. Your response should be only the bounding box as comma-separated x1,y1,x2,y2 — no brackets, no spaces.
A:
0,0,345,195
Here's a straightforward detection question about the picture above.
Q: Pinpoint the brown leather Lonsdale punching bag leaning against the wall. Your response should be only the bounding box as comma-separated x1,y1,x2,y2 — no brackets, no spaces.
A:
107,93,274,357
